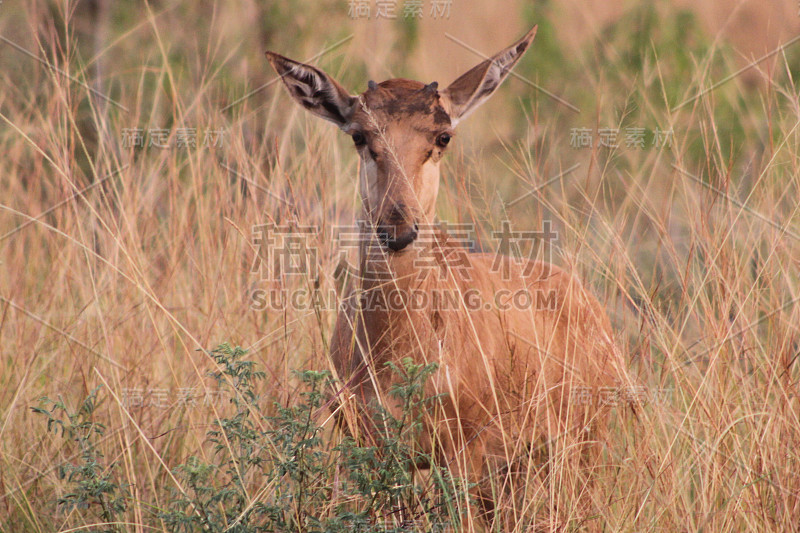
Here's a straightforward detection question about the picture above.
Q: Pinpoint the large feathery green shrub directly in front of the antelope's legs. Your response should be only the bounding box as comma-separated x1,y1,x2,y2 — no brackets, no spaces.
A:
160,344,464,532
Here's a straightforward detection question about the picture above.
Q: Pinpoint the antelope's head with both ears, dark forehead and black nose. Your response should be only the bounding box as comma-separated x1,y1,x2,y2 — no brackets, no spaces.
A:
267,27,536,253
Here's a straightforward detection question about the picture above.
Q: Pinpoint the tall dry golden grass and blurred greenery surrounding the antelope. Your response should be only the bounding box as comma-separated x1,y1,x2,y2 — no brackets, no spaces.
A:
0,0,800,532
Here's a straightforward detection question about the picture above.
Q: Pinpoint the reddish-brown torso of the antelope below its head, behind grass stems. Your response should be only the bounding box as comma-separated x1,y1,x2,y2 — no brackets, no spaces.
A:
331,230,621,481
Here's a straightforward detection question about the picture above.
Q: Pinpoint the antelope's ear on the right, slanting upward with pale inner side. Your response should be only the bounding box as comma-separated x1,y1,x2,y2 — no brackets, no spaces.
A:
442,26,538,126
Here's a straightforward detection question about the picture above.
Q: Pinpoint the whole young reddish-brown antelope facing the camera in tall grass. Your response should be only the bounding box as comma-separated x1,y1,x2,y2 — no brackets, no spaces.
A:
268,28,623,520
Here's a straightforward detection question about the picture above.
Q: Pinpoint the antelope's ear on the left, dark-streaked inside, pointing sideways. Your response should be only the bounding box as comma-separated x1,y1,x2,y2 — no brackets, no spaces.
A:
267,52,358,128
